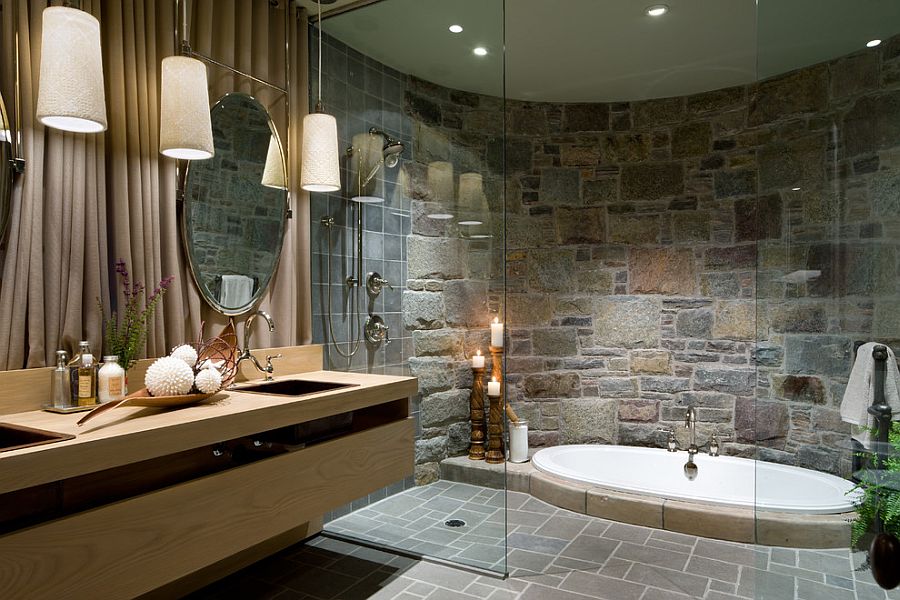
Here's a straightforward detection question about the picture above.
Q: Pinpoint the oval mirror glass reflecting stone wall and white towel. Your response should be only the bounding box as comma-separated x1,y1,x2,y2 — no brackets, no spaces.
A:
181,94,288,316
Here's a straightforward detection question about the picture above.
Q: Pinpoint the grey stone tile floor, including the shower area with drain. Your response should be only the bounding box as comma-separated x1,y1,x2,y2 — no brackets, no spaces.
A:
191,482,900,600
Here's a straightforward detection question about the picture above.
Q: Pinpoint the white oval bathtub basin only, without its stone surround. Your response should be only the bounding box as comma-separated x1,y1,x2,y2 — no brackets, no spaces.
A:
531,445,854,515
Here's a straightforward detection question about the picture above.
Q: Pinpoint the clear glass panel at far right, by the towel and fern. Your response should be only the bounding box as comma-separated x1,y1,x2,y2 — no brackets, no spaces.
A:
752,0,900,598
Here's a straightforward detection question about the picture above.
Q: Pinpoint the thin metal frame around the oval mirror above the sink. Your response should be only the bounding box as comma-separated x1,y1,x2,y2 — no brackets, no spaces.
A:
178,92,292,317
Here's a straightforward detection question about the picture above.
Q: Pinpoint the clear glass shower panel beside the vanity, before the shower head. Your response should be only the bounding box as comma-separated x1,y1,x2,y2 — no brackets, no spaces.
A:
310,0,506,573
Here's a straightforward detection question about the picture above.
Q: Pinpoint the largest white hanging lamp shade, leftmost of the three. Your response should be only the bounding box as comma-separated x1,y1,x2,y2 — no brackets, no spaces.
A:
36,6,106,133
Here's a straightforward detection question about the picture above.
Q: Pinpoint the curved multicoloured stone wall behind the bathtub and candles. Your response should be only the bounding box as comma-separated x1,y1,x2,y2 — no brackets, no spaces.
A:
403,39,900,482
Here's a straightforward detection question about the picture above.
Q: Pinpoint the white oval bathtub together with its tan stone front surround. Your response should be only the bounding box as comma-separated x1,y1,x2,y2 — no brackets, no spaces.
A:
530,445,855,548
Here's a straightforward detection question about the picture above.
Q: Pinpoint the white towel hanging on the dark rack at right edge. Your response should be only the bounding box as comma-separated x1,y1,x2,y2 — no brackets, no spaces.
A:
841,342,900,446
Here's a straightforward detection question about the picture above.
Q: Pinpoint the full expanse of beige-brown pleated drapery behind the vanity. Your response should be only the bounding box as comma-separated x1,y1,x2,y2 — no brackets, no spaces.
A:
0,0,312,369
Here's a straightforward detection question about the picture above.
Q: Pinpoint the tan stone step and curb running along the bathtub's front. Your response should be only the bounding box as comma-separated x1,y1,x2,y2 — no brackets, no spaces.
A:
441,456,855,548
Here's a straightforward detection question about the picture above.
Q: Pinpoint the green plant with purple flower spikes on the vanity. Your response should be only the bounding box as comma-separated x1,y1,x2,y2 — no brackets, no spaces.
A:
97,258,175,370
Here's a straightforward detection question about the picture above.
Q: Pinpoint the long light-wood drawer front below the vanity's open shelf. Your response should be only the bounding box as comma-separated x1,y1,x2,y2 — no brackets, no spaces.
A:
0,418,414,599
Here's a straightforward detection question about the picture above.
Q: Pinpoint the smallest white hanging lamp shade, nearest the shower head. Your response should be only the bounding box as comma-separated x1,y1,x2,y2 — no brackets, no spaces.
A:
300,113,341,192
